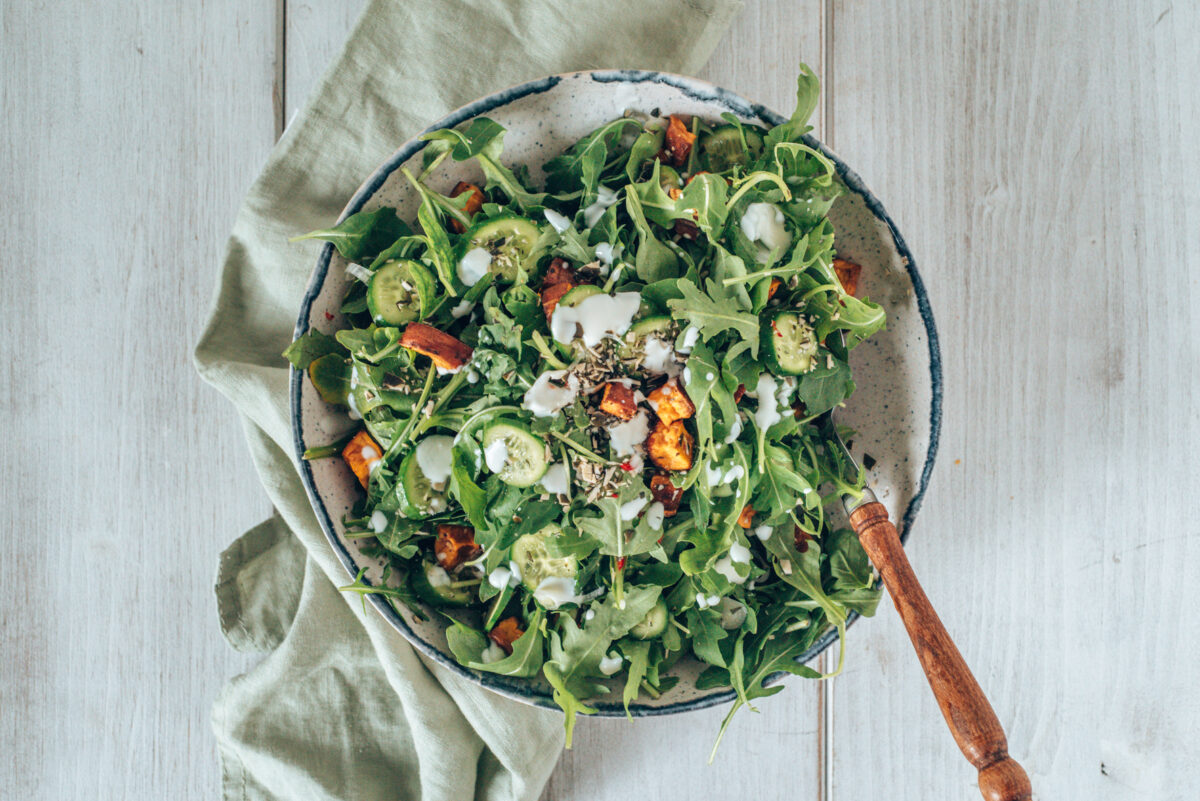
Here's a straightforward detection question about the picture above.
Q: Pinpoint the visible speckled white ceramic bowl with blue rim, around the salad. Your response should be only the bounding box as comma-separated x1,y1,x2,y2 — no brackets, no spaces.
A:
292,70,942,716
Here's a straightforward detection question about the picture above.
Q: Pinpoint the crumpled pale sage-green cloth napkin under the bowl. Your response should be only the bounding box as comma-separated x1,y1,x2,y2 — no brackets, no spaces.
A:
196,0,742,801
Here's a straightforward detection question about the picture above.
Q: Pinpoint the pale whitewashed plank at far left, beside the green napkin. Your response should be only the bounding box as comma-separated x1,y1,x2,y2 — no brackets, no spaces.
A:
0,0,275,799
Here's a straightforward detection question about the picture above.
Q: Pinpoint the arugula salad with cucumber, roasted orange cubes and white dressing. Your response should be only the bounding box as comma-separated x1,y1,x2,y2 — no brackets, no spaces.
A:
284,65,884,745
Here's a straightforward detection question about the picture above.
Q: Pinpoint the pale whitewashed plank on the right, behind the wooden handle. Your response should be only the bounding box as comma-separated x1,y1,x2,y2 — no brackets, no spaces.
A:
833,0,1200,801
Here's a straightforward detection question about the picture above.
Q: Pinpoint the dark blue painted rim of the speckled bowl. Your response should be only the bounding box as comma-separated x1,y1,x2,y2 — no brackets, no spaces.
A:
290,70,942,717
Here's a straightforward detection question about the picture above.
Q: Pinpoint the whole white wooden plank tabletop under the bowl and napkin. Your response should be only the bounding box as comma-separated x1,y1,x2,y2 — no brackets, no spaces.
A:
0,0,1200,801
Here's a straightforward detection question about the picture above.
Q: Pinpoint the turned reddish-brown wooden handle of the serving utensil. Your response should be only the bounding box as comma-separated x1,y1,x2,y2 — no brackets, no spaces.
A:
850,502,1033,801
